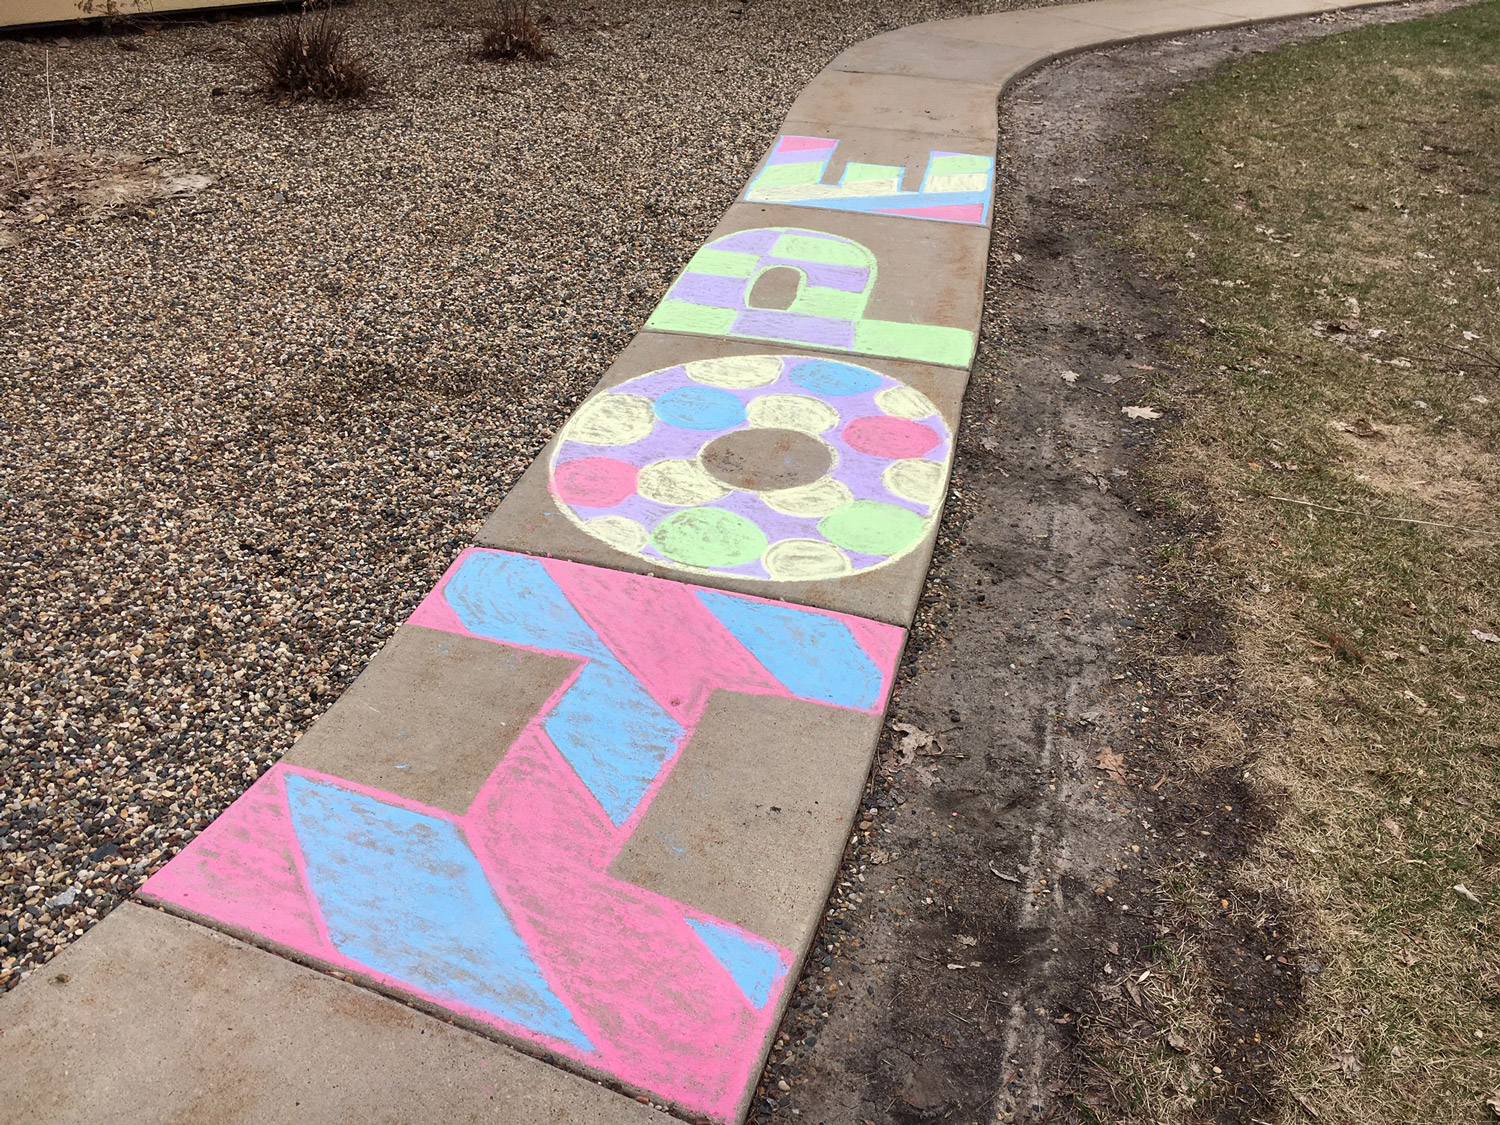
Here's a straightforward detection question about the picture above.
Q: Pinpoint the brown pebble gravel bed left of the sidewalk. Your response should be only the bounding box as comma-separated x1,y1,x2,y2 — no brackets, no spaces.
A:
0,0,1026,989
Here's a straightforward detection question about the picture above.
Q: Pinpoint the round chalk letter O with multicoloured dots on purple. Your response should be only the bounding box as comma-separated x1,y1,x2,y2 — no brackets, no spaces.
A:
551,356,953,582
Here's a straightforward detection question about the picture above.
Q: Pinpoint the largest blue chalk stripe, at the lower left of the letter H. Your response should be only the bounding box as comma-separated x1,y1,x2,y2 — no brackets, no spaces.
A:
287,773,594,1052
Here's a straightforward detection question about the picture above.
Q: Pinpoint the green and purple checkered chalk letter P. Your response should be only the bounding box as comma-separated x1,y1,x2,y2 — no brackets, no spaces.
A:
647,227,975,368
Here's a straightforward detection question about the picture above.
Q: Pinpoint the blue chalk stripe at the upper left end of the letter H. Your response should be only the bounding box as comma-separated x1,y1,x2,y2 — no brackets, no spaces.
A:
443,551,615,662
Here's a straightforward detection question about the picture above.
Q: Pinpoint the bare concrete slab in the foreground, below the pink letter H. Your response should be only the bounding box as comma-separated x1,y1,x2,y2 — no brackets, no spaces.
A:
0,903,663,1125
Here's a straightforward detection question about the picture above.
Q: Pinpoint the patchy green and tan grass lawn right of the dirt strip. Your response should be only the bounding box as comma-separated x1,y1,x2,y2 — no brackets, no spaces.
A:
1098,0,1500,1125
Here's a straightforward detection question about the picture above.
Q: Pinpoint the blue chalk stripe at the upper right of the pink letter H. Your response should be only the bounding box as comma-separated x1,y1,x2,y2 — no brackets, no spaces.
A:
695,590,885,708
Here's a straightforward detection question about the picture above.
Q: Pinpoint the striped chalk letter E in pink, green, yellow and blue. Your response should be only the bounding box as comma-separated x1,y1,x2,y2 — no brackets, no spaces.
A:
744,137,995,227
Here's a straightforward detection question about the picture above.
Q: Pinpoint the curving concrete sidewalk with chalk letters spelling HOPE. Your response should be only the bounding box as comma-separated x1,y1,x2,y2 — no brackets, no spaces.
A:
0,0,1404,1124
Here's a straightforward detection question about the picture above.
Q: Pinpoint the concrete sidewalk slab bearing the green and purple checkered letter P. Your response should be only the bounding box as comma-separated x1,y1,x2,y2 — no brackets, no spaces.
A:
647,203,990,369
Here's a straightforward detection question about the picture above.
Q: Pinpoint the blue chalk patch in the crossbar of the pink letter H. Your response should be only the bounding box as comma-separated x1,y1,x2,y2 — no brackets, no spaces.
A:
542,662,684,825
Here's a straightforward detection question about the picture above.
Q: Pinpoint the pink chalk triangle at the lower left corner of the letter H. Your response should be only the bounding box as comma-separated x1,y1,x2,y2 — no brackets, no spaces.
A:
141,765,338,957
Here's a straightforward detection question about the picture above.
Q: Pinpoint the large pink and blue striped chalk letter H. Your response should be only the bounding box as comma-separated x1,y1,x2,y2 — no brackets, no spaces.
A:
143,549,902,1121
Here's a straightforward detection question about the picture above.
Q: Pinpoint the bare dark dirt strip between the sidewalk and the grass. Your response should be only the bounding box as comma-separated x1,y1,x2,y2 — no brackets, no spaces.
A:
752,6,1470,1125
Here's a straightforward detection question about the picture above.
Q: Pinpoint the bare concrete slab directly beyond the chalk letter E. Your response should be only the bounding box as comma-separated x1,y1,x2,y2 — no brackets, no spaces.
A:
783,71,999,141
